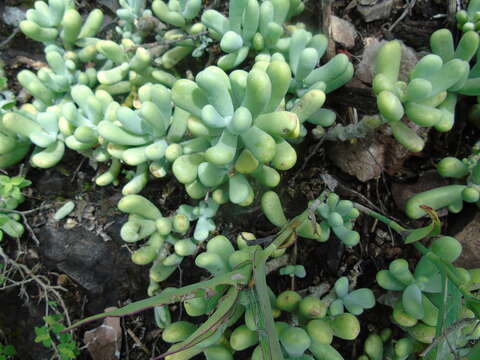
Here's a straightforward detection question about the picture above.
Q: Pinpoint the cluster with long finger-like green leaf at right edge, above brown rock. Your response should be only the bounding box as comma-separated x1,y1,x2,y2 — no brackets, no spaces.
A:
405,143,480,219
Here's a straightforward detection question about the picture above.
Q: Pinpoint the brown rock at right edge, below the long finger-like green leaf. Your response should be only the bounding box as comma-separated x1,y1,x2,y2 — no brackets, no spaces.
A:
454,212,480,269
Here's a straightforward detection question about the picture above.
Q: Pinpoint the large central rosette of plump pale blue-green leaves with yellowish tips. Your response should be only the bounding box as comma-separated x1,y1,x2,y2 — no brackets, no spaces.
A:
172,61,300,206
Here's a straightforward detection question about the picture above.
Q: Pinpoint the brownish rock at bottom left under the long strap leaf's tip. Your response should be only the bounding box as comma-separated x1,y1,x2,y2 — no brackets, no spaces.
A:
83,307,122,360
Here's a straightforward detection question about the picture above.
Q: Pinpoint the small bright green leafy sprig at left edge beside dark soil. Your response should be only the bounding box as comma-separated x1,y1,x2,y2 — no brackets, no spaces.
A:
0,175,31,241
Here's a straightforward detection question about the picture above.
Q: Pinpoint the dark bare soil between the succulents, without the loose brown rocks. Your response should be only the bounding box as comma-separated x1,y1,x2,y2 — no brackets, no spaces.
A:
0,0,479,360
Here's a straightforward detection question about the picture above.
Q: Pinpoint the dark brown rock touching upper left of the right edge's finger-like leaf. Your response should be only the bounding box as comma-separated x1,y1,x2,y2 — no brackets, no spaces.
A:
392,169,448,212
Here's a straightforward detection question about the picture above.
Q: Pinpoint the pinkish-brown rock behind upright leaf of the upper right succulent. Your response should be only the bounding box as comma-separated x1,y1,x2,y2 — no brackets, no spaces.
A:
356,37,418,84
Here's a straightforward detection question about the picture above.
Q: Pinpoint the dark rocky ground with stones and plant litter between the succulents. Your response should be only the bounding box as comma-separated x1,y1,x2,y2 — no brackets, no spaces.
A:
0,0,480,360
